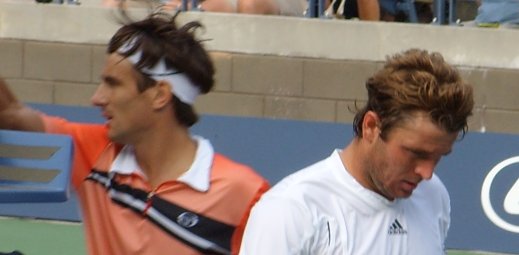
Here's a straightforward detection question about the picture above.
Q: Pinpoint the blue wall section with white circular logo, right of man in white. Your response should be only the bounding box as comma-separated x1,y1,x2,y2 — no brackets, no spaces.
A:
437,132,519,254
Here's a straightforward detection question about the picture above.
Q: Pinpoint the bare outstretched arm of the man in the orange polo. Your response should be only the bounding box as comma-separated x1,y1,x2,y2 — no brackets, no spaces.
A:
0,78,44,132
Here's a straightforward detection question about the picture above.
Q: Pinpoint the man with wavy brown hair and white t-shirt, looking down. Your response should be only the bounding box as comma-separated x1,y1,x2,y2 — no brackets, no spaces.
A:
240,49,474,255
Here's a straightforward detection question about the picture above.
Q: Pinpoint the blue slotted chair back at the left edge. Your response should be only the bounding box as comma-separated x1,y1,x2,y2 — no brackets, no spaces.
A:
0,130,73,203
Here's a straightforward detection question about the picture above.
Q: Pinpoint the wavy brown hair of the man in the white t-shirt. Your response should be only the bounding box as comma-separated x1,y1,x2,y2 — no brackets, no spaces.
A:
353,49,474,139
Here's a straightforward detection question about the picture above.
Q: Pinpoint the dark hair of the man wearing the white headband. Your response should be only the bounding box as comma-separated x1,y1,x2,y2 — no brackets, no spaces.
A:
107,8,215,127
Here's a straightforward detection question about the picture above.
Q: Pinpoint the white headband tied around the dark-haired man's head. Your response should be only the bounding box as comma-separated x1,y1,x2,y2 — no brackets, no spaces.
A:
117,40,200,105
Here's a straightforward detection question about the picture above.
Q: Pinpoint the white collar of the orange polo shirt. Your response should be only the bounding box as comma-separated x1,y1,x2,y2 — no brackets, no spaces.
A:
109,136,214,192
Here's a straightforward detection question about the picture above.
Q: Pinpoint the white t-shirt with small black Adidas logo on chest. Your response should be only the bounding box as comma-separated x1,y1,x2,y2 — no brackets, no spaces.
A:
240,150,450,255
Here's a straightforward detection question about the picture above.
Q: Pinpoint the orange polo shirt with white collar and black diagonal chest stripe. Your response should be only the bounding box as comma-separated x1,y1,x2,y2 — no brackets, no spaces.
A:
43,116,269,255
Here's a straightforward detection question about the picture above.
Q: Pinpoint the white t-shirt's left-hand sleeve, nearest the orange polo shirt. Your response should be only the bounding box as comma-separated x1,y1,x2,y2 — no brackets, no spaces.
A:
240,194,314,255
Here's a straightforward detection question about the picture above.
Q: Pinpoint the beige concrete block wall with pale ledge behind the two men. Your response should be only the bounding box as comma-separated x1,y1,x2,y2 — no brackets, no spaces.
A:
0,0,519,133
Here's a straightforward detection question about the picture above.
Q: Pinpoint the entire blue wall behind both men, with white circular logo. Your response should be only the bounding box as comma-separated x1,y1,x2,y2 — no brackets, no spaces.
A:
0,104,519,253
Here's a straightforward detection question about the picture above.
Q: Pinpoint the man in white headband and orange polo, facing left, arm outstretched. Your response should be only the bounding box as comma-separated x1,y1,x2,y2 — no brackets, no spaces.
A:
0,8,269,255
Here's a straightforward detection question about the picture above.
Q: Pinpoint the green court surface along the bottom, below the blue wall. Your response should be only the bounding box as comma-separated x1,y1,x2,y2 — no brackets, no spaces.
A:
0,217,512,255
